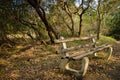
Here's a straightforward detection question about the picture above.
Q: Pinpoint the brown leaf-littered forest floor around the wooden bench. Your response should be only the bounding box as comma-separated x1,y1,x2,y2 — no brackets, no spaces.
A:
0,43,120,80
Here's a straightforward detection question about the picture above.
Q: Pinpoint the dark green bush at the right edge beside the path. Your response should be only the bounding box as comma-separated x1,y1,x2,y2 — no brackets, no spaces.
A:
109,9,120,40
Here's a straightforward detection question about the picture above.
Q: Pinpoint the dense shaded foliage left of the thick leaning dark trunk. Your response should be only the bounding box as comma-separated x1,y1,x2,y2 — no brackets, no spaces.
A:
0,0,47,42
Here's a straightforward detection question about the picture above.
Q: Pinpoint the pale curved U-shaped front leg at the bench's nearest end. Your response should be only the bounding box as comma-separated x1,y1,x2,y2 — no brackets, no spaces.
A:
65,57,89,76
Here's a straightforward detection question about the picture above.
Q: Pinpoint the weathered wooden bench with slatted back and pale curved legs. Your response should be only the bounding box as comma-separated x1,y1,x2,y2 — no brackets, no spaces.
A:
55,36,113,76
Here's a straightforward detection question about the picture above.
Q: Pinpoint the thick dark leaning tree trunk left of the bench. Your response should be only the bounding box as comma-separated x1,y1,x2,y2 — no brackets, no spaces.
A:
27,0,59,43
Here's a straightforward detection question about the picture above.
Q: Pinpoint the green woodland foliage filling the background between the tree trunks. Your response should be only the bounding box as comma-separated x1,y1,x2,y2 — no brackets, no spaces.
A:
0,0,119,41
